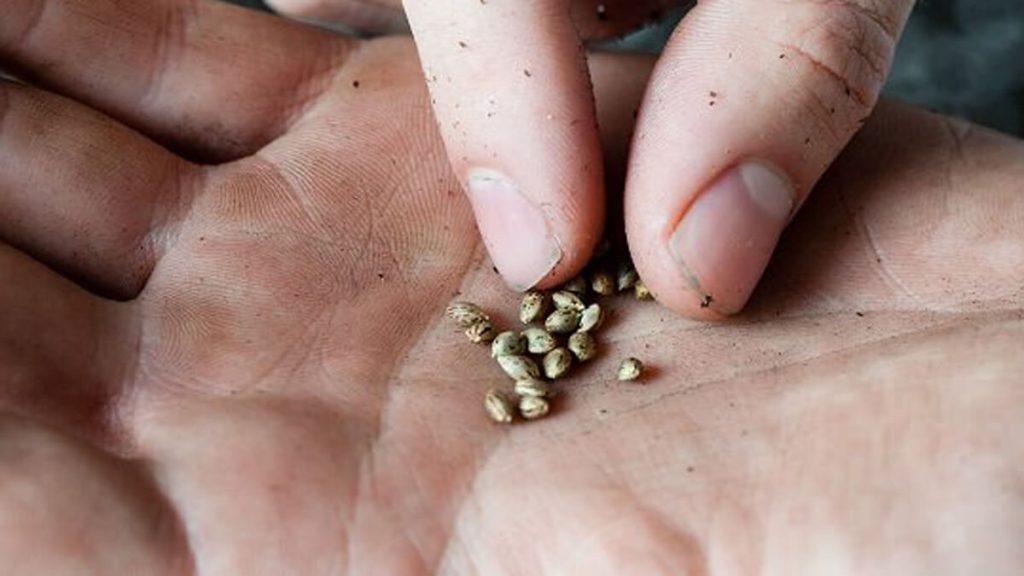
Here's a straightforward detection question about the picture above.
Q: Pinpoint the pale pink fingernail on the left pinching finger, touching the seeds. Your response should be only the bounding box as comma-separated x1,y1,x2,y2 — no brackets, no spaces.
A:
467,169,562,290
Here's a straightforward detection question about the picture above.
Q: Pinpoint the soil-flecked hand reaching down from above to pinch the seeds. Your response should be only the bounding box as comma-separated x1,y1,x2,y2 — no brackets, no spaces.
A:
272,0,913,319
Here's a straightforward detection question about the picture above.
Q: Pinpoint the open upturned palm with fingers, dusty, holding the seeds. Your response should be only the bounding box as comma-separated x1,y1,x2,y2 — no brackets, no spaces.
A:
0,0,1024,576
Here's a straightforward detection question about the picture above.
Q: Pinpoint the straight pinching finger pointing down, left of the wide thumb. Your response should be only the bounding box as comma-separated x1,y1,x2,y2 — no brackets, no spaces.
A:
404,0,604,290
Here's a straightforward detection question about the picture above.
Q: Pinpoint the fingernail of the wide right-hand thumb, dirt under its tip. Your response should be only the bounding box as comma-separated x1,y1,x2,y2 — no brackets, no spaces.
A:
669,161,795,314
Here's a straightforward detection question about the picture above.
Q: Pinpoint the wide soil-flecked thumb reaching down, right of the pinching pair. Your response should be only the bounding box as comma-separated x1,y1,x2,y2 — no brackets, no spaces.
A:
626,0,912,318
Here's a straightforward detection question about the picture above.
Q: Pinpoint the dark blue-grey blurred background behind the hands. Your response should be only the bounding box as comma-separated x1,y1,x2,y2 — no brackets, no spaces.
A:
229,0,1024,136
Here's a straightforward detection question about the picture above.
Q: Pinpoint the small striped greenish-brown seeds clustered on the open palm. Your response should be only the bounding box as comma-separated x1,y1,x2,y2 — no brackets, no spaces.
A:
445,258,651,423
